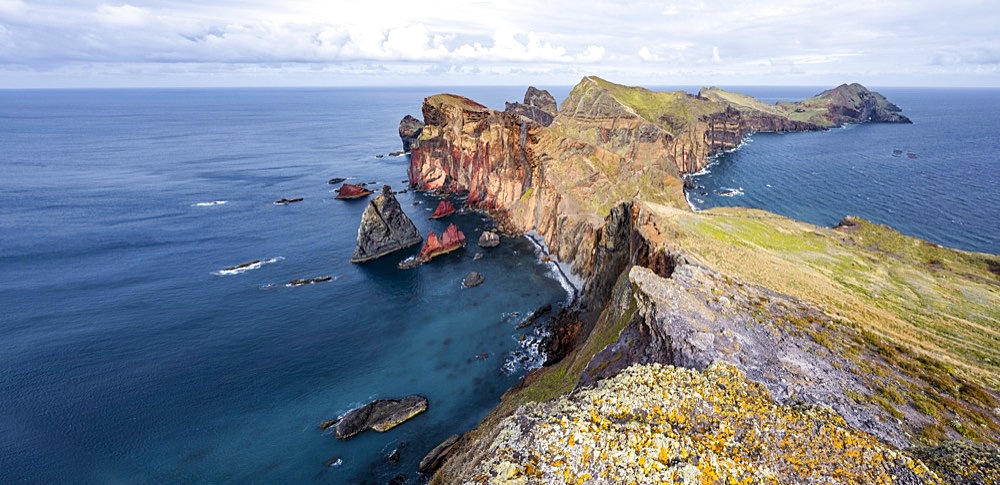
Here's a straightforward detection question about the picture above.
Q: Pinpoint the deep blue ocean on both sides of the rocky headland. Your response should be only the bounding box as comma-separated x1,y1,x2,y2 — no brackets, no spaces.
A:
0,87,1000,483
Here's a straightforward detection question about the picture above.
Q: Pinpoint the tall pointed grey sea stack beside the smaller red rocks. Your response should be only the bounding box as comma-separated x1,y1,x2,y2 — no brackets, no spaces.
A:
351,185,423,263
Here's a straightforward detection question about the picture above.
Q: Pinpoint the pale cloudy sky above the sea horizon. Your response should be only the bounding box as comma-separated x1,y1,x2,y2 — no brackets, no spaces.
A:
0,0,1000,88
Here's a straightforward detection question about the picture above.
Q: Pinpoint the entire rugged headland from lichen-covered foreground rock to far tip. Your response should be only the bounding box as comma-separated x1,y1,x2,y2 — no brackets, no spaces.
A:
400,76,1000,483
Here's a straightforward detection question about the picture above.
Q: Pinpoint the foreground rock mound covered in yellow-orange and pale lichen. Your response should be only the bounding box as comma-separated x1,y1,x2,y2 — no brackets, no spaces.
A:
466,363,940,484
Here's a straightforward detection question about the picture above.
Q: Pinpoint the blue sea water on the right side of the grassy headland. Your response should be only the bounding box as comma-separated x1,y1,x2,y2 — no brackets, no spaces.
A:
688,87,1000,254
